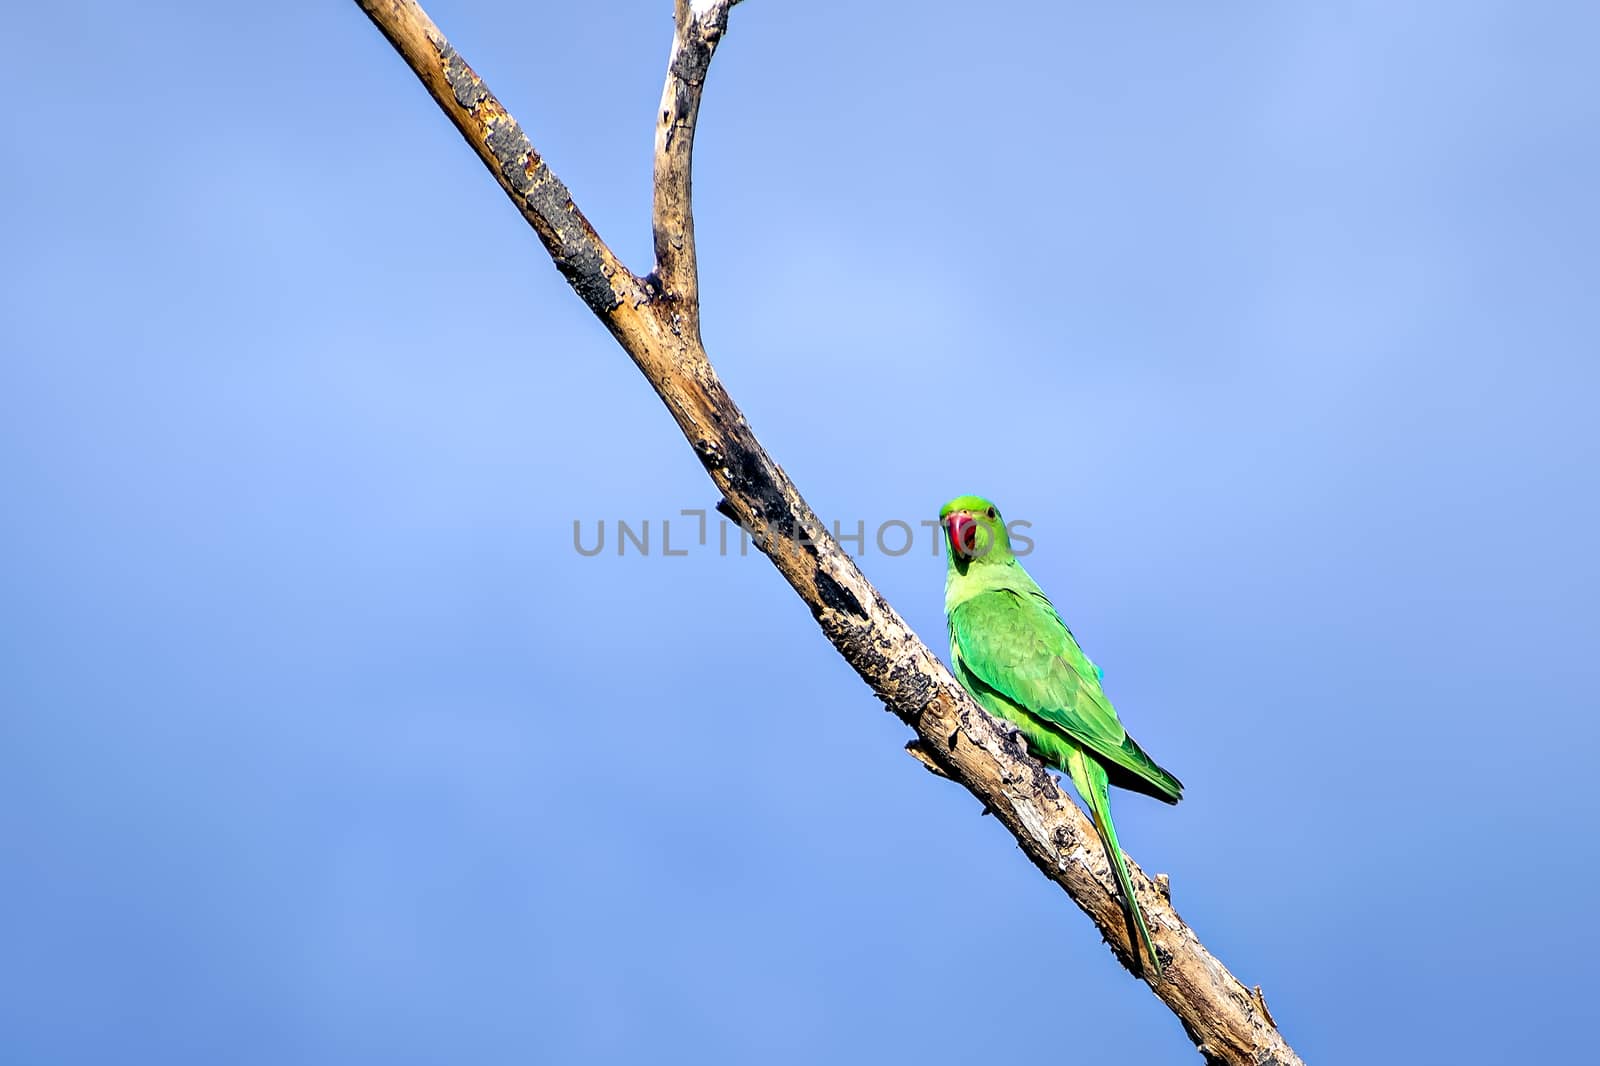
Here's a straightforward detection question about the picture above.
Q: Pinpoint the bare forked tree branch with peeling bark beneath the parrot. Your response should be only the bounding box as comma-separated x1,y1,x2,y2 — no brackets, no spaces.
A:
357,0,1301,1066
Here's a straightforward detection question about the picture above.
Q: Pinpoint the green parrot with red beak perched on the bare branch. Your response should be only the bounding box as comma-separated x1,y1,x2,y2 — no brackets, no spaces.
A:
939,496,1184,978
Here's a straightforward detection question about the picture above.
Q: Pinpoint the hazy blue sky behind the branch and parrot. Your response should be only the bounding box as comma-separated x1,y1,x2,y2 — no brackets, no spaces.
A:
0,0,1600,1066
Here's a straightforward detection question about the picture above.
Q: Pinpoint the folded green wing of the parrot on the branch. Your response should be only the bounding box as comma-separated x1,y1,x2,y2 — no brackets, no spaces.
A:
950,589,1184,804
